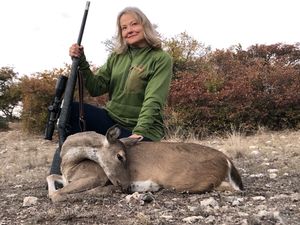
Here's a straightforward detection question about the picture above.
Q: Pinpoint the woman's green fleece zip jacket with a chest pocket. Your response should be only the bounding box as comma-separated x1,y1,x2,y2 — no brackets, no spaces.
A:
79,47,173,141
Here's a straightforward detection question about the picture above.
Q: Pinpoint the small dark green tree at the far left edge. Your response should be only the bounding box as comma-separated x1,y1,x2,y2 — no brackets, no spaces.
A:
0,67,21,120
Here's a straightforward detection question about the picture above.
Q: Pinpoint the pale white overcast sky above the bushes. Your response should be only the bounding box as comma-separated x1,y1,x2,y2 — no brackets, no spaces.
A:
0,0,300,76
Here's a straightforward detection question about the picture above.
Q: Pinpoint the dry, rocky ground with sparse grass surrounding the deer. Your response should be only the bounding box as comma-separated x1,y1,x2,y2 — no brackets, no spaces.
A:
0,124,300,225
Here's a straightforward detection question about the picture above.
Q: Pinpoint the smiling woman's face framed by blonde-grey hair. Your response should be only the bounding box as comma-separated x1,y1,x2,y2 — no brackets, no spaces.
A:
120,13,147,48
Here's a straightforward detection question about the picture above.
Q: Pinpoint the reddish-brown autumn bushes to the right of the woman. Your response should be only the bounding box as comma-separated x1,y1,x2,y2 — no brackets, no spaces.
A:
166,44,300,135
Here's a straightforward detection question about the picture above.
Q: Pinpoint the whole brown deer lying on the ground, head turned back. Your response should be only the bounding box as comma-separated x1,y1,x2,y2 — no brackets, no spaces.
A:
47,126,244,201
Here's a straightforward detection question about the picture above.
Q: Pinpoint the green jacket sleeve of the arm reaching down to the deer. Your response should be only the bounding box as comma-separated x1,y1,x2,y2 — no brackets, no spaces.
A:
133,53,173,135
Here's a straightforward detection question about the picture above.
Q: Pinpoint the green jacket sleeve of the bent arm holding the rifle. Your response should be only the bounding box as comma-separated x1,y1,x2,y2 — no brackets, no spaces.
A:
79,55,111,97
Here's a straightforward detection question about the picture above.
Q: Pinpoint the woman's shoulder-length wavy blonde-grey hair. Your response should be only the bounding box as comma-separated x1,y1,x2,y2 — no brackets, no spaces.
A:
114,7,162,54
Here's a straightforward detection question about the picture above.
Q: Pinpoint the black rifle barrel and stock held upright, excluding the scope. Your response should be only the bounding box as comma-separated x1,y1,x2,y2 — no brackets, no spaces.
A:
50,1,90,174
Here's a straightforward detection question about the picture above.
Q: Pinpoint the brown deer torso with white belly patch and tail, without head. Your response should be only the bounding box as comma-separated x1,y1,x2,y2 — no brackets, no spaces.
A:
122,142,243,193
